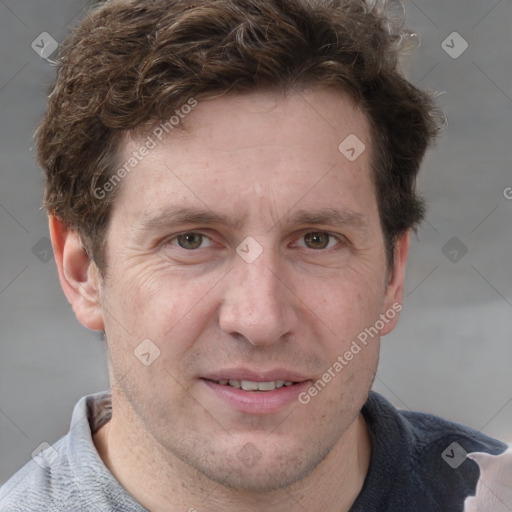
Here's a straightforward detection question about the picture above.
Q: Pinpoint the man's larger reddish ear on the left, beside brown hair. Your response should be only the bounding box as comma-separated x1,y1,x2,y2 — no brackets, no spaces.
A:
50,216,104,331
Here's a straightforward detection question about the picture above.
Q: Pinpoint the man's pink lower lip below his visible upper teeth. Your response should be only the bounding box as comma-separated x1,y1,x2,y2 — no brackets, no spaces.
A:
201,379,311,414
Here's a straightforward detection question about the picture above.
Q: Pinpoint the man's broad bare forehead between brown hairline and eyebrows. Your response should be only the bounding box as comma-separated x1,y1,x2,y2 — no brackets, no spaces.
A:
114,89,375,229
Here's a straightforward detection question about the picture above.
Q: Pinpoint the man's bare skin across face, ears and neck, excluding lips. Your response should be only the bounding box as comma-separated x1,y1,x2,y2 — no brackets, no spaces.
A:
50,89,409,512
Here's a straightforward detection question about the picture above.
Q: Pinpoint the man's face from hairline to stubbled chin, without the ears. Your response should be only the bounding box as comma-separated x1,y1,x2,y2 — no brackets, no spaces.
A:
93,90,400,491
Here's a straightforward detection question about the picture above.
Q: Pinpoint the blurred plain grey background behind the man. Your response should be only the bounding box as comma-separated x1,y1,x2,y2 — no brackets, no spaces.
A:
0,0,512,483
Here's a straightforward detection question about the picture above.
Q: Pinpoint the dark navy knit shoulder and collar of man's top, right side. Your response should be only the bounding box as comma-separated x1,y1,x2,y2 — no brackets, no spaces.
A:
363,392,507,511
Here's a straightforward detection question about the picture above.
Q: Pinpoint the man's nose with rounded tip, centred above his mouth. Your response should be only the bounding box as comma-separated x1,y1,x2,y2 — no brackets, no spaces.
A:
219,252,299,346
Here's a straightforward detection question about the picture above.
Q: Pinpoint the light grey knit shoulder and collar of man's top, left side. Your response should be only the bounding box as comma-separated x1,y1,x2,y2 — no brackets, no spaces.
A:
0,392,145,512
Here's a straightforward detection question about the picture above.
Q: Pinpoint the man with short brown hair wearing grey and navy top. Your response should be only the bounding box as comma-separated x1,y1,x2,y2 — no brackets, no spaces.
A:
0,0,510,512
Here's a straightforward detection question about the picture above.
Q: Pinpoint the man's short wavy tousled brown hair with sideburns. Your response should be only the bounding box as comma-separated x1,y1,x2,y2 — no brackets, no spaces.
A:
36,0,441,270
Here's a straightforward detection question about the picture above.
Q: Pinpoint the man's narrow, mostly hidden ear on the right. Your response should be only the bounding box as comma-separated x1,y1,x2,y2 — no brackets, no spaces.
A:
381,230,411,336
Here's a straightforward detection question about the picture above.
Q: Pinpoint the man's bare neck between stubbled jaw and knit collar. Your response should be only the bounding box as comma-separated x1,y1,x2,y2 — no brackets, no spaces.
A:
94,396,371,512
